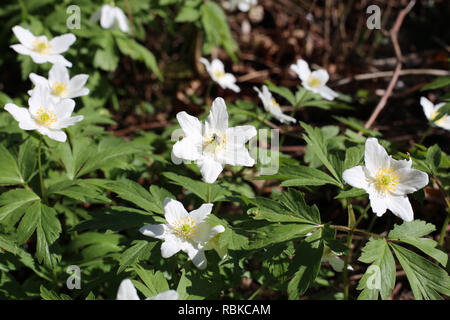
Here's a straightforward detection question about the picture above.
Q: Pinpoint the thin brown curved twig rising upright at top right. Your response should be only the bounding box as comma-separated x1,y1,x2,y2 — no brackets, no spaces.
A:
365,0,416,129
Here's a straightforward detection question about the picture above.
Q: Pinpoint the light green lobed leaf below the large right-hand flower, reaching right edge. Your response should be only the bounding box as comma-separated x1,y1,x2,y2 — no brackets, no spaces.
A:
388,220,448,267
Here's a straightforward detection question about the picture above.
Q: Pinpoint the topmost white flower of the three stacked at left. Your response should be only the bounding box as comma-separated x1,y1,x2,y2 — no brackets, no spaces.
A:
11,26,76,67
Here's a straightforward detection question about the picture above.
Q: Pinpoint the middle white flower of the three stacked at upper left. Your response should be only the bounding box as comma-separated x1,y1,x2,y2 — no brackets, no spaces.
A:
28,63,89,101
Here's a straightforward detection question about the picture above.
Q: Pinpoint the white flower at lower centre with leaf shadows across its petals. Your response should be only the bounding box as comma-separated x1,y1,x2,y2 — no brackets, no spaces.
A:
139,198,225,269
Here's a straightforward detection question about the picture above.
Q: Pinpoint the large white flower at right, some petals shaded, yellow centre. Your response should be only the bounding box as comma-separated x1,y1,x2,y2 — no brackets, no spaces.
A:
343,138,428,221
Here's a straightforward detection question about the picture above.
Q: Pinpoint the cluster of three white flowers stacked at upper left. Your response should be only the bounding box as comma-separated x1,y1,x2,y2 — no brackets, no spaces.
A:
5,26,85,142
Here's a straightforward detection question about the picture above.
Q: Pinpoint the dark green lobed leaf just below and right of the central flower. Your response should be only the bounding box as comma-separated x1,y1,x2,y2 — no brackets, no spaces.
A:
249,189,320,226
